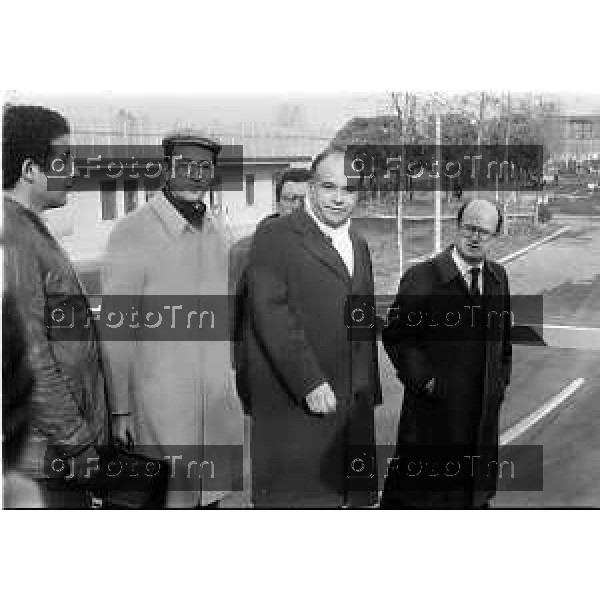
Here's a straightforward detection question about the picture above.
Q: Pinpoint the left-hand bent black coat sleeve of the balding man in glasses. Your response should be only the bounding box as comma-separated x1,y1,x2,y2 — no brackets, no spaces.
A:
382,265,434,393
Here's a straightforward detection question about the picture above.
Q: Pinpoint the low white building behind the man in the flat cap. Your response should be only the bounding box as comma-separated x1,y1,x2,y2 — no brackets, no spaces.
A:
46,121,329,262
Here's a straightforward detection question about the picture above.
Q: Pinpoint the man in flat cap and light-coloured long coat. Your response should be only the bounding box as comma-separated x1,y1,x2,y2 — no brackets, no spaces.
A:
103,130,243,508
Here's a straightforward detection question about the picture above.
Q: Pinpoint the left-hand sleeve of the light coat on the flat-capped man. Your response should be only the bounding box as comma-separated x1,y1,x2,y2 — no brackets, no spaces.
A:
102,221,144,412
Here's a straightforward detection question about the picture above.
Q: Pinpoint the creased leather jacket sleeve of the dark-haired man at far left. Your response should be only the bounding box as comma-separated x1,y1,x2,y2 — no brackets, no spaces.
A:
4,235,100,455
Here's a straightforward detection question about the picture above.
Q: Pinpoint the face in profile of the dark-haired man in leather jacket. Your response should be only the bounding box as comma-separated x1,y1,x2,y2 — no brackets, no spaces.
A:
32,134,73,210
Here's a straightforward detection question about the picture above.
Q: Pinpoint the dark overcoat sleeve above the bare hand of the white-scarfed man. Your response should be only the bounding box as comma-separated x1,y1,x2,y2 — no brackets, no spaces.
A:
248,228,327,403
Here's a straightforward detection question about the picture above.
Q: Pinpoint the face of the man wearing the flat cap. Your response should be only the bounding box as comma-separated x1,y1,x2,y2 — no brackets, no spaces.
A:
167,145,214,202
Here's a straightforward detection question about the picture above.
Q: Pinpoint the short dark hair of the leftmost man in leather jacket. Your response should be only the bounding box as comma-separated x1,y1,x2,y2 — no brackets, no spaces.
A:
2,104,70,190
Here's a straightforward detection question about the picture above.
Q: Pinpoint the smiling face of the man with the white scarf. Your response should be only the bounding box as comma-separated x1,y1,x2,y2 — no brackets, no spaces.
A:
310,152,358,227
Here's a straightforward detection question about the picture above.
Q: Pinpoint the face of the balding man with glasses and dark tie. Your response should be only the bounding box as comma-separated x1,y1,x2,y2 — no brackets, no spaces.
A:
455,200,498,264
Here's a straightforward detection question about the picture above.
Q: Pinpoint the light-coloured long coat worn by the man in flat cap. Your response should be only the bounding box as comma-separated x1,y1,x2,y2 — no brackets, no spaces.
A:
103,194,244,508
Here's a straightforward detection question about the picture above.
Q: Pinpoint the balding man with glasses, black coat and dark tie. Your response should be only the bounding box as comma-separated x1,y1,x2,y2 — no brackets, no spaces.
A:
382,199,512,508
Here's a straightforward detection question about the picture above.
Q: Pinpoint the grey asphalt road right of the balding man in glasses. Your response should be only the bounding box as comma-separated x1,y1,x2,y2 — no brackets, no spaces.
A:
494,218,600,508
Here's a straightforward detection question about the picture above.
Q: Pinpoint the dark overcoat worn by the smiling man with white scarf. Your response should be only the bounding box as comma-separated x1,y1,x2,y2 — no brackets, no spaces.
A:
244,210,381,507
